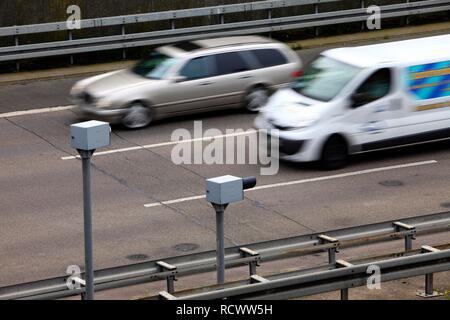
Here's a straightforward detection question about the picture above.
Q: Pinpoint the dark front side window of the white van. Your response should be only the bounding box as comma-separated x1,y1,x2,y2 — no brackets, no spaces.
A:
355,68,392,106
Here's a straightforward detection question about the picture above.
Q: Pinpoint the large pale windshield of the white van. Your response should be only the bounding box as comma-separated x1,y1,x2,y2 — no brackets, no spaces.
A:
292,56,360,101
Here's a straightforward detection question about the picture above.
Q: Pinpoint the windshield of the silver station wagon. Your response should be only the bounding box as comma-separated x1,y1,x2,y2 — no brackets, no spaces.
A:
132,51,177,79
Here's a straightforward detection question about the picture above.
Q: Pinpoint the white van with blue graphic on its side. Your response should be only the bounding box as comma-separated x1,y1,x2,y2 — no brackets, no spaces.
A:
255,35,450,169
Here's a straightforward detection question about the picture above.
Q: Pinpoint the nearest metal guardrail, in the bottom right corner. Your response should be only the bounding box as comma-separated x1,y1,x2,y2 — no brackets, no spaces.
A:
161,245,450,300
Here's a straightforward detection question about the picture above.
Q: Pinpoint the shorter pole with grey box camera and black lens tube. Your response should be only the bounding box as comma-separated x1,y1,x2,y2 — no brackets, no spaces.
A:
206,176,256,284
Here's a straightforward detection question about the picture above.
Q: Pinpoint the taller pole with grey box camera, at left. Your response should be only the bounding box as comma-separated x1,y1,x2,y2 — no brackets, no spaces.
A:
70,121,111,300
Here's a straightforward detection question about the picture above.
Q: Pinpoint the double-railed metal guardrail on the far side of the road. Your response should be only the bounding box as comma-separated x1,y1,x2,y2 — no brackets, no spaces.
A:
0,0,450,62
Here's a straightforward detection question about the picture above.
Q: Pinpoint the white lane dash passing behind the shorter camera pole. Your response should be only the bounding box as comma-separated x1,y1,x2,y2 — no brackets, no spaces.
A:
144,160,437,208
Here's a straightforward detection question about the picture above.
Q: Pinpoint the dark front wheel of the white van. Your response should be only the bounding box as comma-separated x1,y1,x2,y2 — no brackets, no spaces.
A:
320,136,348,170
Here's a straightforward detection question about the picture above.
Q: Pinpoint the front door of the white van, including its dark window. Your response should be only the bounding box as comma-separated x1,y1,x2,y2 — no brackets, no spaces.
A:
350,68,401,151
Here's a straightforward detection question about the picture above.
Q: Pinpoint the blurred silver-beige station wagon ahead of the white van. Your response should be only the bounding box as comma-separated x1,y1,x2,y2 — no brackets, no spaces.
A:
71,36,302,128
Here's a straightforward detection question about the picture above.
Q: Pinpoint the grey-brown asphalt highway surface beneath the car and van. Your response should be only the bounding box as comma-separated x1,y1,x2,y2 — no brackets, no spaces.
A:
0,38,450,298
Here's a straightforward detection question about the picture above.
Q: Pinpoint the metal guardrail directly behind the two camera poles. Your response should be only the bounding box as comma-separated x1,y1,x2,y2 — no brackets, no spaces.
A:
0,212,450,300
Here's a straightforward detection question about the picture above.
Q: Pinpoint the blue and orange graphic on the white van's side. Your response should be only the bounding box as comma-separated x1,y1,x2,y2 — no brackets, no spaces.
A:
408,61,450,100
